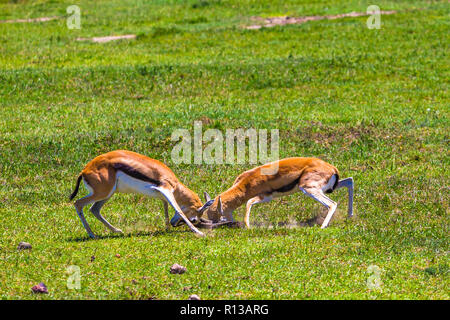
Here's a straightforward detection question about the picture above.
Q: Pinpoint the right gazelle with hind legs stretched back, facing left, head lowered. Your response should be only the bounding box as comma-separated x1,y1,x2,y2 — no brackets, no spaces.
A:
200,158,353,228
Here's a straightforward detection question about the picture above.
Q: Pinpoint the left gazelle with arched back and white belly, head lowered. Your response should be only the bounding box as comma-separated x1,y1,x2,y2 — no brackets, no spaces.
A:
70,150,211,238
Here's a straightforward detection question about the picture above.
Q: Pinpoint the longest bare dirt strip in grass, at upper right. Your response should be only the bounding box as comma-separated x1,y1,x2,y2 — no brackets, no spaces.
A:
243,11,396,29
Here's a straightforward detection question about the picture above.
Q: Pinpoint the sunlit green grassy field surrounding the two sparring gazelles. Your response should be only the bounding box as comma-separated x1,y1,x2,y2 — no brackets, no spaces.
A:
0,0,450,299
